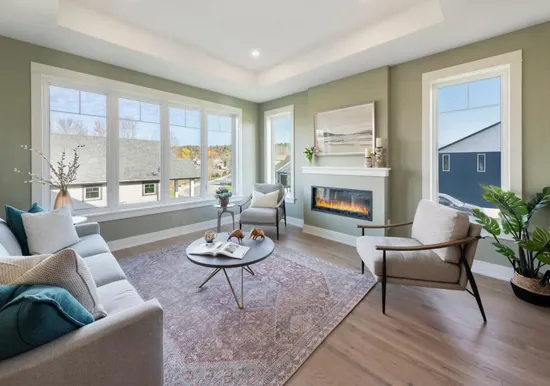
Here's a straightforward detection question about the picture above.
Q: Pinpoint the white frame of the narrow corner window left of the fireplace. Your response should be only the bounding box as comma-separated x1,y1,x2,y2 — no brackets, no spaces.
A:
264,105,296,204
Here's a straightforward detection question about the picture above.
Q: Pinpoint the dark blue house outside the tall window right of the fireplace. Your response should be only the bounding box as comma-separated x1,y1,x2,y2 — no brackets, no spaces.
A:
439,122,501,207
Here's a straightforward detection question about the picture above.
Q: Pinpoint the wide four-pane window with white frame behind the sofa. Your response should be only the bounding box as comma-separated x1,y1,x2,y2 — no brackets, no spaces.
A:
31,63,242,219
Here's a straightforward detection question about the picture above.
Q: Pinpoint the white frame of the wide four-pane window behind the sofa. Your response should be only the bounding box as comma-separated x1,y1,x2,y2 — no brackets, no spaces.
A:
31,62,243,221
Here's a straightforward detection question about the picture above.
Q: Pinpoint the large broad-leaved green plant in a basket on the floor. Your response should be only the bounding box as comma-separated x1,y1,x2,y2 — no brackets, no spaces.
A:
473,186,550,306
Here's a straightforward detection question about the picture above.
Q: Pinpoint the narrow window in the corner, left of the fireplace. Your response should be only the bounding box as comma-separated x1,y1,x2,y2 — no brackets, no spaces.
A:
264,106,294,202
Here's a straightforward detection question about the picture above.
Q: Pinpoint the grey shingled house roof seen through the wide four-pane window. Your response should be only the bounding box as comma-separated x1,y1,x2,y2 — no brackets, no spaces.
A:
50,133,201,184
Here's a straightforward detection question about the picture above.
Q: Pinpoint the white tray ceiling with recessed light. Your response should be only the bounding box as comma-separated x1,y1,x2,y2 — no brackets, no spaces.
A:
0,0,550,102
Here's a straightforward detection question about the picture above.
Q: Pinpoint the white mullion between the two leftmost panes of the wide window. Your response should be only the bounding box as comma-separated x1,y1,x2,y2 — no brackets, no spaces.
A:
106,92,120,209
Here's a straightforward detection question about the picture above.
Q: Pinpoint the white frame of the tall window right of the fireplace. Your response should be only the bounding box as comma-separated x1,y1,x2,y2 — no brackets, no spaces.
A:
422,51,523,202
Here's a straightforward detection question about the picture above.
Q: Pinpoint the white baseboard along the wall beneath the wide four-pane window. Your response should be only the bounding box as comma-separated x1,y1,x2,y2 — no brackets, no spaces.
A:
107,214,240,251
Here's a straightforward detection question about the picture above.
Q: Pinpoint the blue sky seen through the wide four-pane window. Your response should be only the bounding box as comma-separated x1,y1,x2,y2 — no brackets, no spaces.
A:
50,86,232,146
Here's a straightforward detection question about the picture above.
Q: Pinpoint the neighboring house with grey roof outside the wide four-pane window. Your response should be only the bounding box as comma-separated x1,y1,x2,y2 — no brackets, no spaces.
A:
50,133,200,209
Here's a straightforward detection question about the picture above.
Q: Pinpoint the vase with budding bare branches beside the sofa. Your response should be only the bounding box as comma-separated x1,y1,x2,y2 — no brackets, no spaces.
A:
14,145,84,209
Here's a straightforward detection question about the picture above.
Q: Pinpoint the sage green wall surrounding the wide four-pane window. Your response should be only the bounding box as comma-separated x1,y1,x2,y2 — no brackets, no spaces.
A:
0,37,259,240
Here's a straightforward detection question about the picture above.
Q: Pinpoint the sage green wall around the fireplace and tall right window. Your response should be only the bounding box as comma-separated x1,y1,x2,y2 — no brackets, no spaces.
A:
260,23,550,265
